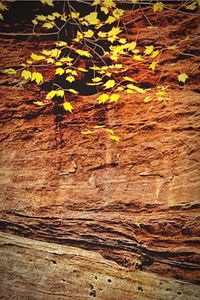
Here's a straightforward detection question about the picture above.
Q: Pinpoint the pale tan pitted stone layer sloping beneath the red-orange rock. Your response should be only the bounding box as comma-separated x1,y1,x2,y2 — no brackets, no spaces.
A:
0,234,200,300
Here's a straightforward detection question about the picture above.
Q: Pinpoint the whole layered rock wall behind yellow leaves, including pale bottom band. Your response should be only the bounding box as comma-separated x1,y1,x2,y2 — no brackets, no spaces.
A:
0,2,200,300
